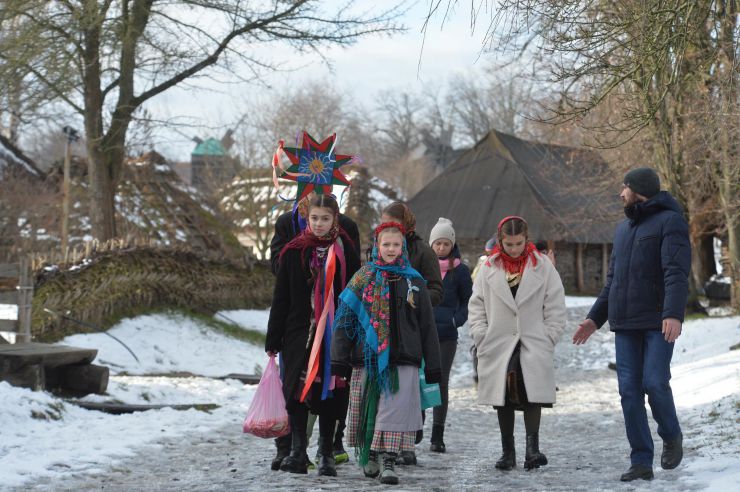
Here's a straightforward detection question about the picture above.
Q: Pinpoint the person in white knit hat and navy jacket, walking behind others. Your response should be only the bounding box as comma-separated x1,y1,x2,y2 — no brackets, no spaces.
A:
429,217,473,453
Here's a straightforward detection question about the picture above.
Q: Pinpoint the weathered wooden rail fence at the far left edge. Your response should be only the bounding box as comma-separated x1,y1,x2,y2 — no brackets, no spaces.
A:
0,256,33,343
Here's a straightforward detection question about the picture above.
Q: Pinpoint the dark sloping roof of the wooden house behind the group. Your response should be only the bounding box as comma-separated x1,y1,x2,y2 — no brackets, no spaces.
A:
409,131,622,243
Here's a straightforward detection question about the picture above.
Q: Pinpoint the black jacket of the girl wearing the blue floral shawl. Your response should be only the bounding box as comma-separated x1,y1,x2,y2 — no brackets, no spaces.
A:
331,273,442,383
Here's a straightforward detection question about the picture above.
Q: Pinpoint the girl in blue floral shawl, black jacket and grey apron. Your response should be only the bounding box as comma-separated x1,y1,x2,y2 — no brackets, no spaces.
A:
332,222,440,484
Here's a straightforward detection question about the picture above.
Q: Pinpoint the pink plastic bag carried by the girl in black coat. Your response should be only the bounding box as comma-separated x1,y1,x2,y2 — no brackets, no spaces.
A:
243,355,290,438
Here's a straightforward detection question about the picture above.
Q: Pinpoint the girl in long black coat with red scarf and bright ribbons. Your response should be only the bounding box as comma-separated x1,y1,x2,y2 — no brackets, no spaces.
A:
265,195,360,476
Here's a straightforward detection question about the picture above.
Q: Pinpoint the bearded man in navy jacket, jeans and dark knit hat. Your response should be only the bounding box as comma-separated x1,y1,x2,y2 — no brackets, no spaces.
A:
573,168,691,482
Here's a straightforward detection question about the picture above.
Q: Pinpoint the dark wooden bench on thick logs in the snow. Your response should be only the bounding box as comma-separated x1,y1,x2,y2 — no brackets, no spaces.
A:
0,343,109,394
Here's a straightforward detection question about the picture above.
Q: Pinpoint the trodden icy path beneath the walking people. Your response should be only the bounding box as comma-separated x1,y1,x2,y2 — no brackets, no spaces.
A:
24,308,737,491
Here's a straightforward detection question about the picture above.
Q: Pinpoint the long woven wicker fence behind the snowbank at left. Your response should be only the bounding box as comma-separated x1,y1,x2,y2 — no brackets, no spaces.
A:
32,244,274,341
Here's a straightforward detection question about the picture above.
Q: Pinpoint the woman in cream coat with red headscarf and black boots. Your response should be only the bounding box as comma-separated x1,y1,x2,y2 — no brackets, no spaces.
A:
468,217,566,470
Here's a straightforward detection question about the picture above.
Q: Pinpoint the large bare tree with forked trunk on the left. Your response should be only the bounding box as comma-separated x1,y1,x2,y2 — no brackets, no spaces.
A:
0,0,398,239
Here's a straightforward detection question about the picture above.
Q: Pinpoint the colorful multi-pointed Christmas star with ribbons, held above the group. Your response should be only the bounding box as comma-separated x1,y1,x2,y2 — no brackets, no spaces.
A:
272,131,355,201
